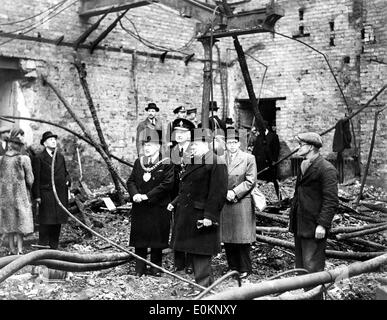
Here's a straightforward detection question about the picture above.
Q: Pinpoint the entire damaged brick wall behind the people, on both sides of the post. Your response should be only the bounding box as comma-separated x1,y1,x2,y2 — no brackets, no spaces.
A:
0,0,387,186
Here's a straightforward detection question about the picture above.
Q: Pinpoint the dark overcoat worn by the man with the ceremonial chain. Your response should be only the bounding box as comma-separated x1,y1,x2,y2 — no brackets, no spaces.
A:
127,157,173,248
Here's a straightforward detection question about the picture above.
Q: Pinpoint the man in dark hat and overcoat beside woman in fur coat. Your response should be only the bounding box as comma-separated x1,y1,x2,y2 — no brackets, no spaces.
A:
32,131,71,249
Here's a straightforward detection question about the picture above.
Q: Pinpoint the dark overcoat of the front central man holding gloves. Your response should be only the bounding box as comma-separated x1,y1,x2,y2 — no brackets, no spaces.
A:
171,151,227,255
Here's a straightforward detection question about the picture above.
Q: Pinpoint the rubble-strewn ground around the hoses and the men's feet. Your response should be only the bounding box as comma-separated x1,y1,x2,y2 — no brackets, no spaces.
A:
0,180,387,300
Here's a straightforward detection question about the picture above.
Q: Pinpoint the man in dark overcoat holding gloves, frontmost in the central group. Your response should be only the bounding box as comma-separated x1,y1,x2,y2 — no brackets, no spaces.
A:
168,129,227,286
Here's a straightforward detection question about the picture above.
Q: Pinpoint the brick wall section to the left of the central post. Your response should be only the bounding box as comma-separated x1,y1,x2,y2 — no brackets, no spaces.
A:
0,0,222,187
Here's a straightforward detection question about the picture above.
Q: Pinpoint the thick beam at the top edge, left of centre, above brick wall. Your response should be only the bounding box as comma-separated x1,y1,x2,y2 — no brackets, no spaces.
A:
79,0,152,18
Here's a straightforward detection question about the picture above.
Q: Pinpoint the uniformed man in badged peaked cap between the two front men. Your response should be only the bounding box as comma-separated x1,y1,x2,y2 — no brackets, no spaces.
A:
171,118,195,274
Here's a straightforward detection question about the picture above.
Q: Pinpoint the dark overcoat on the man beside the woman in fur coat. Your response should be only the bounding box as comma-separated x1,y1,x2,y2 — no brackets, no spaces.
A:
32,149,71,224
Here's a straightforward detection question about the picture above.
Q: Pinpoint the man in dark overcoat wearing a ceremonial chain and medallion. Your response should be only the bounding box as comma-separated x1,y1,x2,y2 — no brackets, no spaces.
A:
127,129,174,277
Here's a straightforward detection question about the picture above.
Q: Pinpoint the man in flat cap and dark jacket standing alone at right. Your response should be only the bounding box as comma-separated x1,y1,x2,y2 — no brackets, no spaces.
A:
289,132,339,299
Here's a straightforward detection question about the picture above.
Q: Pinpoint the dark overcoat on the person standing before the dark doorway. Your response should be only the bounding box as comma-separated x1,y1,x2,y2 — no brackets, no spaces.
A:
252,130,280,181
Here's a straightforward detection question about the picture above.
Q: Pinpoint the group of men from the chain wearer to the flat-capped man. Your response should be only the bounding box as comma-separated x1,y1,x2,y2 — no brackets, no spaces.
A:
131,102,338,298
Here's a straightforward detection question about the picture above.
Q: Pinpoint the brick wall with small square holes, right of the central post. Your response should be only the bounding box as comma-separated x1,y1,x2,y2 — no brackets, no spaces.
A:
222,0,387,184
